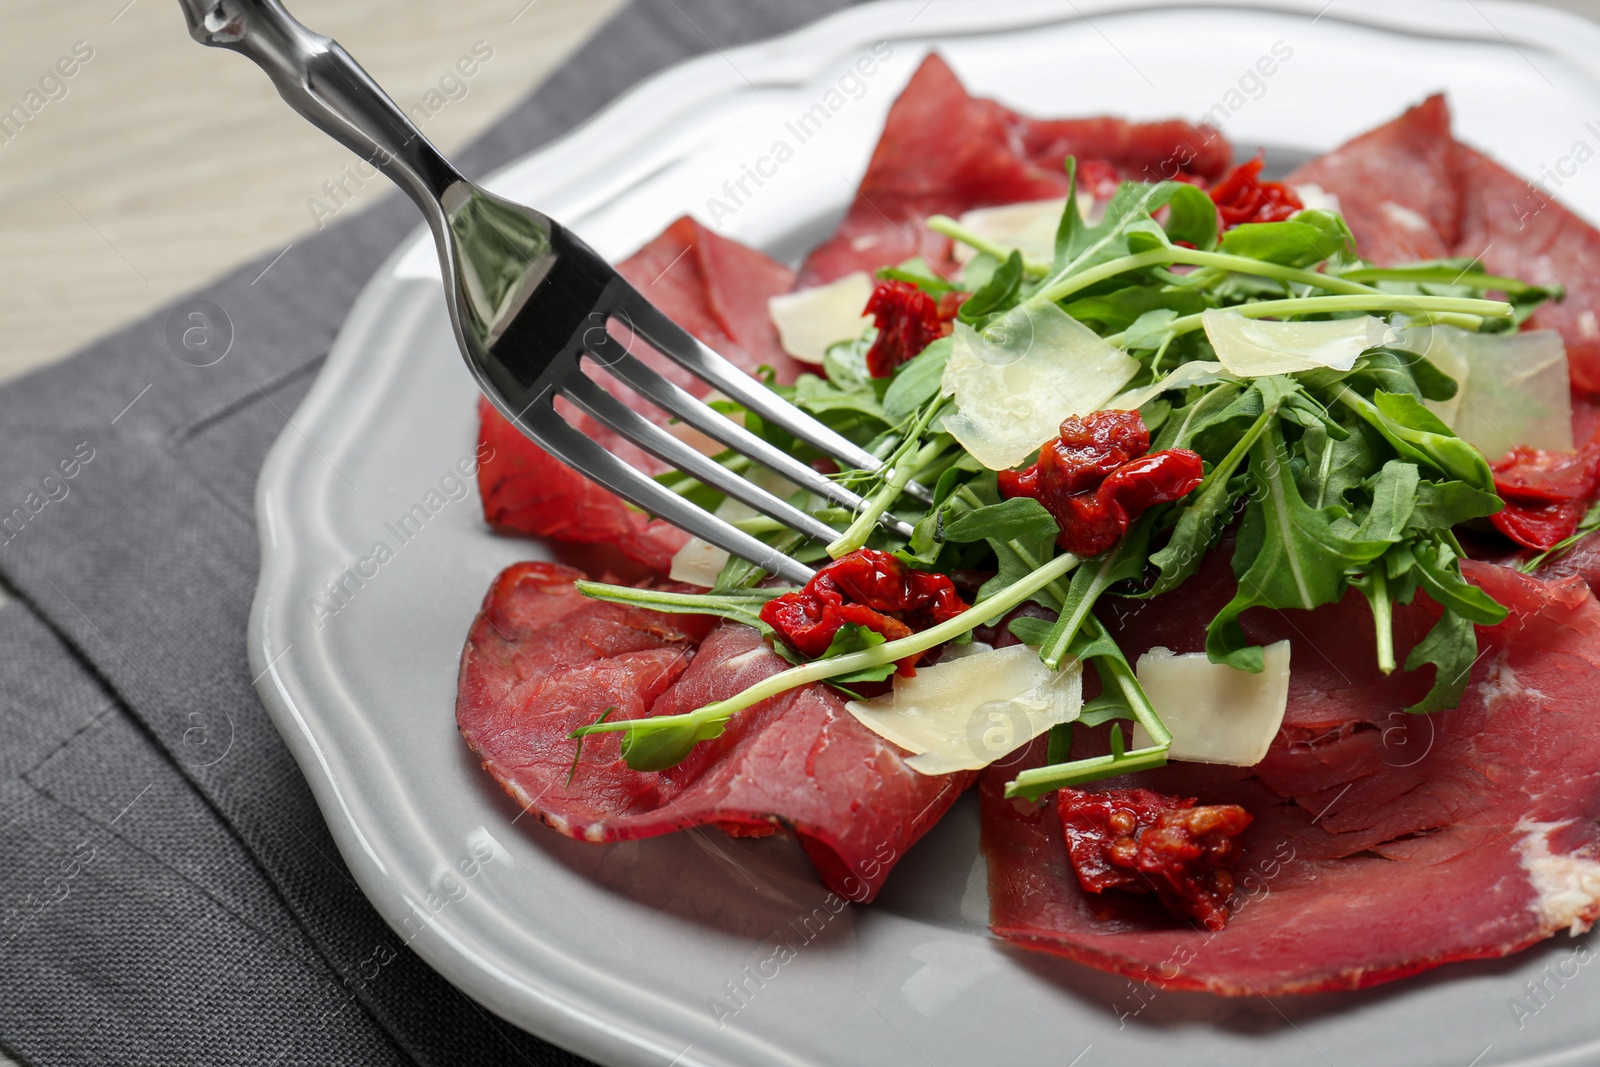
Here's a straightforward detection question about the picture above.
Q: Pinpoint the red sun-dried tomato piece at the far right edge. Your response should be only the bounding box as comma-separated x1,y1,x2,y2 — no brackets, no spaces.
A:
1490,445,1600,552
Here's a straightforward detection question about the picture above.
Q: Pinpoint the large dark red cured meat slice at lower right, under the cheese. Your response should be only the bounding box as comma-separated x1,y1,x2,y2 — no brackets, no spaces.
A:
981,558,1600,995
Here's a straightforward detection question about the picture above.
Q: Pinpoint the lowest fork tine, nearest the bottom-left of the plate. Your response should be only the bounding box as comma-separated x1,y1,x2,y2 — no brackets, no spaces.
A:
502,400,814,585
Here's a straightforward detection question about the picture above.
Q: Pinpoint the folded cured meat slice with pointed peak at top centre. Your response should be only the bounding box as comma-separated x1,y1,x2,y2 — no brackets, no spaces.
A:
800,54,1232,286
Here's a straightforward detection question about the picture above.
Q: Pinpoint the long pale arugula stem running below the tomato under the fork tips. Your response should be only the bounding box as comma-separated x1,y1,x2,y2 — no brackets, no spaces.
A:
571,553,1078,737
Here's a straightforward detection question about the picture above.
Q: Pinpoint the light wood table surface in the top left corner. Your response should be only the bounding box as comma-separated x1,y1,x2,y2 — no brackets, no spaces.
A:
0,0,621,381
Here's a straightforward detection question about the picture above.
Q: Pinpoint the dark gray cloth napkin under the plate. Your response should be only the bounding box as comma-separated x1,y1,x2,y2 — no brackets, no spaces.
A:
0,0,845,1067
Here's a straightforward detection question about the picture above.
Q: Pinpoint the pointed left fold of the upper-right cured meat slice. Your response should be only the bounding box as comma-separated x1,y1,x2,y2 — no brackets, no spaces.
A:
1285,96,1461,267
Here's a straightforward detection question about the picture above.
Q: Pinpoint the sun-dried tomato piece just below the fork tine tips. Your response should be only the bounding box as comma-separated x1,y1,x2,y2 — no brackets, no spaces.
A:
762,549,966,675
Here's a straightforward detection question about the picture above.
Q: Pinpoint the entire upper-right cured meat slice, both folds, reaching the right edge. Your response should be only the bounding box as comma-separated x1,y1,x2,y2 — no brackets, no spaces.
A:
1288,96,1600,391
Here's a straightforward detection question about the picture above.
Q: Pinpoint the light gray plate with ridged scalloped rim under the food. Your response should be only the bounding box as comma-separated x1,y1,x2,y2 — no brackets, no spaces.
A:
250,0,1600,1067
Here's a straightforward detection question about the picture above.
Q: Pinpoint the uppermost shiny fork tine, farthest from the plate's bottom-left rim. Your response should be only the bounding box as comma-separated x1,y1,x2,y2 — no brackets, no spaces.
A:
614,291,933,504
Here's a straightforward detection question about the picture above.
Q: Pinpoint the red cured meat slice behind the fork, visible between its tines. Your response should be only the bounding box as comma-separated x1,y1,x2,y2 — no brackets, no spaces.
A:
478,218,800,569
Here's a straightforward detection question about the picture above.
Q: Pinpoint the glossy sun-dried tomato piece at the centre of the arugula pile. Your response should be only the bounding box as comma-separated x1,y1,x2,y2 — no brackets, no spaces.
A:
998,411,1205,557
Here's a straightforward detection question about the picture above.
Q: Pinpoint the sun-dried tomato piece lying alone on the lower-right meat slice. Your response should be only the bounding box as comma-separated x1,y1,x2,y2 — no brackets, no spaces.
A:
1056,789,1250,929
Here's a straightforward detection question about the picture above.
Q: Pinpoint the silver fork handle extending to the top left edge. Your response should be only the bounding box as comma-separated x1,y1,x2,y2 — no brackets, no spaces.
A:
179,0,461,224
